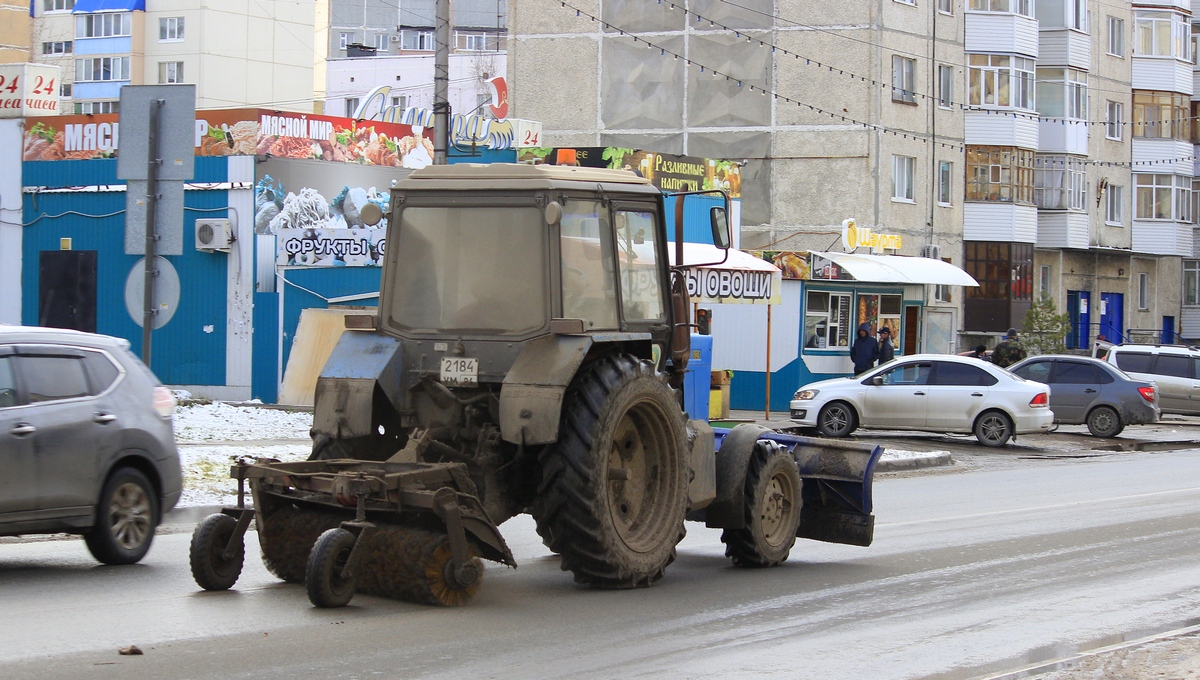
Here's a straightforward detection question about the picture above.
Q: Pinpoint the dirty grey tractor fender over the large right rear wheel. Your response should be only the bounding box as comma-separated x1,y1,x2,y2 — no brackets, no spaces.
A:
500,335,593,444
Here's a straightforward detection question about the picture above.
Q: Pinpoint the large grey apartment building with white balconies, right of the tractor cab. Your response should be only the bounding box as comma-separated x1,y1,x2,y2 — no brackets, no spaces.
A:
509,0,1200,350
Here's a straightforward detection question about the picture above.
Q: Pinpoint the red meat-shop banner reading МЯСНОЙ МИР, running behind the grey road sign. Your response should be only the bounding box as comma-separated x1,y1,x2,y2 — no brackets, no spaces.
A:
22,109,433,169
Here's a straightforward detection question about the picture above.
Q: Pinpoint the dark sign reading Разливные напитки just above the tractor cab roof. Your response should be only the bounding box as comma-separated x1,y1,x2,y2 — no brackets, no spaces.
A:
517,146,742,198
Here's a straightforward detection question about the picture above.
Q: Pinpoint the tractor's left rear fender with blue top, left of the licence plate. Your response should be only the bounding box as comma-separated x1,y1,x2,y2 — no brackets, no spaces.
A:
312,331,401,439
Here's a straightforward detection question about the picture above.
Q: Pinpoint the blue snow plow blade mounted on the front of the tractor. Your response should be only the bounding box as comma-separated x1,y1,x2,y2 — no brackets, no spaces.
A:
713,428,883,546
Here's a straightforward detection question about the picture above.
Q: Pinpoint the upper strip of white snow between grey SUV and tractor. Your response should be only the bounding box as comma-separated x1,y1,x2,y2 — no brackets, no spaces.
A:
175,402,312,444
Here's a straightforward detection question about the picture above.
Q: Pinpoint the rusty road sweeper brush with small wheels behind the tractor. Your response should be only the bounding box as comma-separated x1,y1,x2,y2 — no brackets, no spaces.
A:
192,459,516,607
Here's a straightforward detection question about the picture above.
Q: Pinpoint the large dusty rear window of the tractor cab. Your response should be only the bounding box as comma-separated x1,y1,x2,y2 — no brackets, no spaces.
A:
386,206,547,335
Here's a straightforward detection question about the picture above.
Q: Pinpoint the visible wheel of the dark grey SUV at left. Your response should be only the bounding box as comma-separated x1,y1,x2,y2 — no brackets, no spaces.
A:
84,468,158,565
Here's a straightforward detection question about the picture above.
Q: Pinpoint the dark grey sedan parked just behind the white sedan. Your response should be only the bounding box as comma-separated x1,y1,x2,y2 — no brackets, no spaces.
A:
1008,355,1159,437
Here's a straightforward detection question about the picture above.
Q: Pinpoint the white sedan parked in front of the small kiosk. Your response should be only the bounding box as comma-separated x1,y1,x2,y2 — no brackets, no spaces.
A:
791,354,1054,446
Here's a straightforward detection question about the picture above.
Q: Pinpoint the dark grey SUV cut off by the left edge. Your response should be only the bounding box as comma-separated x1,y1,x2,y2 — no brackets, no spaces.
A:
0,325,182,565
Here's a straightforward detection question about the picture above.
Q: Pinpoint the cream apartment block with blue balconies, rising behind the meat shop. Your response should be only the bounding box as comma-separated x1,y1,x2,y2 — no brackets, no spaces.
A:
31,0,313,114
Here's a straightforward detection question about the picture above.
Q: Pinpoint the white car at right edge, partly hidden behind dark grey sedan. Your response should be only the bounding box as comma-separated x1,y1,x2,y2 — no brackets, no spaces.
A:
1104,344,1200,415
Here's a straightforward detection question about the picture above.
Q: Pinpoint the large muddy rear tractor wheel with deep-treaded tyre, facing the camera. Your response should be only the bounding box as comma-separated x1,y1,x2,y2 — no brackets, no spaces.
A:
532,355,688,588
